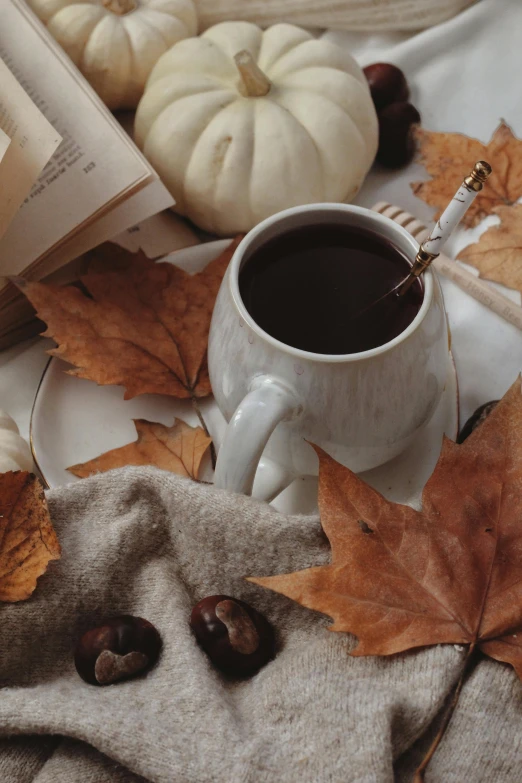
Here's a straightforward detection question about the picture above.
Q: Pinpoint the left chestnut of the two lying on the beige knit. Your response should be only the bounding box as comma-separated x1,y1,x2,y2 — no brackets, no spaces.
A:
74,614,161,685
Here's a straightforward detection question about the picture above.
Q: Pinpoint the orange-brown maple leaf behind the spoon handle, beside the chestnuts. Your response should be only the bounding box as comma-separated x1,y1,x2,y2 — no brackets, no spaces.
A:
411,121,522,226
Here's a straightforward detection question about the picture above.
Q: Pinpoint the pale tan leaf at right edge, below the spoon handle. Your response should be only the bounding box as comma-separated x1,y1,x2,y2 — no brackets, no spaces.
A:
458,204,522,292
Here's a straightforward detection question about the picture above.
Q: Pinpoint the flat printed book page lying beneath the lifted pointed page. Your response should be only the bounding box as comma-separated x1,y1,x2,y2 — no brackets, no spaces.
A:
0,0,161,275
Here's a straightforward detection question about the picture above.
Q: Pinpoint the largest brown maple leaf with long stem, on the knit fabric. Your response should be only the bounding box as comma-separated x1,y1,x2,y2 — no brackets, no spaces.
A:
250,378,522,781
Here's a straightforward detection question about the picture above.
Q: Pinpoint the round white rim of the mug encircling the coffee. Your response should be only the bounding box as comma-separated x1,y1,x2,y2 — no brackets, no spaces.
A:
228,202,435,364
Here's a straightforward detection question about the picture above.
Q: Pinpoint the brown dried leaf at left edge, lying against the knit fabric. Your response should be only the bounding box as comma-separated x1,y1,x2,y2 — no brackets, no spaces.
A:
0,471,60,601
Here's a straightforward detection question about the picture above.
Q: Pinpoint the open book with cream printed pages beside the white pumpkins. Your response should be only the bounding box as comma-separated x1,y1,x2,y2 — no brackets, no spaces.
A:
0,0,193,347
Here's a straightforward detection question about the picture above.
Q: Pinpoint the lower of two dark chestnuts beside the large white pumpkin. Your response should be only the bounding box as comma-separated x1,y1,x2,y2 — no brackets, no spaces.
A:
377,102,420,168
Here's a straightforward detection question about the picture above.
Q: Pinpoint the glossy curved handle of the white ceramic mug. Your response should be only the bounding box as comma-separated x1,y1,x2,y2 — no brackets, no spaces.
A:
214,376,302,497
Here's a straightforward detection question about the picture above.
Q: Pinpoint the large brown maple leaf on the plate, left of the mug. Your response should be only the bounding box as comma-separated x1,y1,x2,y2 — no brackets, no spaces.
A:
16,238,239,400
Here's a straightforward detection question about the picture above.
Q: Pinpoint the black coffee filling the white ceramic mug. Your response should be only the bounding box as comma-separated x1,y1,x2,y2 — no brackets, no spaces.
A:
239,225,423,354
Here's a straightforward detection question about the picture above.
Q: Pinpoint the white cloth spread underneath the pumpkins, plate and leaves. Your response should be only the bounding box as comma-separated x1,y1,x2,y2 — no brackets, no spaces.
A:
0,0,522,436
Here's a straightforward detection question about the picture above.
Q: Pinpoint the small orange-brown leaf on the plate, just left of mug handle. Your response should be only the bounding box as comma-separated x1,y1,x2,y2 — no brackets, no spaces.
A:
67,419,212,479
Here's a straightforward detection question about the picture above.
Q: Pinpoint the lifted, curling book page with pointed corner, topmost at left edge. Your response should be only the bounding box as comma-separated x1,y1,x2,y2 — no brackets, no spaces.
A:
0,59,62,238
